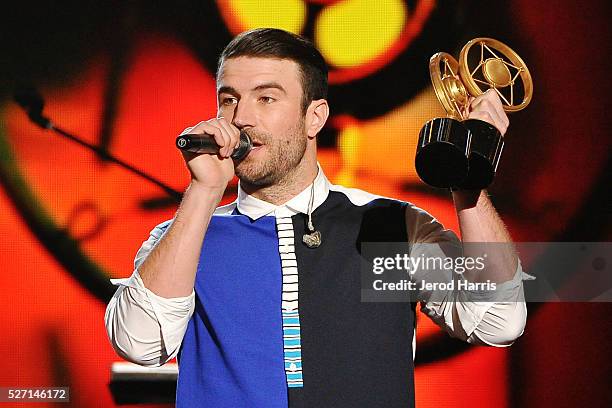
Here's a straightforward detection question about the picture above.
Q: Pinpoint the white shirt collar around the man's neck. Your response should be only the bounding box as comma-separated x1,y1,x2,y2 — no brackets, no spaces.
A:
236,165,330,220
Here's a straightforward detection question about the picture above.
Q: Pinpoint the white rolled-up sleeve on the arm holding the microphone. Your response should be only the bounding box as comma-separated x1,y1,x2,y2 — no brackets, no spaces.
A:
104,222,195,366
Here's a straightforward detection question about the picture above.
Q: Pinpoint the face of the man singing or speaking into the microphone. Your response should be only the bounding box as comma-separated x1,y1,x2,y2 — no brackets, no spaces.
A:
217,57,307,186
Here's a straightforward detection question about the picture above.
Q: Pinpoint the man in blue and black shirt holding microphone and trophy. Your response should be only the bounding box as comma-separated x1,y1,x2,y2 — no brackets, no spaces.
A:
105,29,526,407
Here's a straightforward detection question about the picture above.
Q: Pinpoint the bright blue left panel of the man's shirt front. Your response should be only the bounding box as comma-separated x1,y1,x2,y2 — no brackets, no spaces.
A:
176,215,288,408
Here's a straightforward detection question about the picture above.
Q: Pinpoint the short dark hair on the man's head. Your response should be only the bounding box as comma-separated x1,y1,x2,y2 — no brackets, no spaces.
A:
217,28,327,112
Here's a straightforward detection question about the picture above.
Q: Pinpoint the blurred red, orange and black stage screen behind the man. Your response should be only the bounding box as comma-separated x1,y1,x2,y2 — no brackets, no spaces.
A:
0,0,612,407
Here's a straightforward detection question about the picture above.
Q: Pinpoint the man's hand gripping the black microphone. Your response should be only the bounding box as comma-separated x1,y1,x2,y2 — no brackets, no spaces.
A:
181,117,240,193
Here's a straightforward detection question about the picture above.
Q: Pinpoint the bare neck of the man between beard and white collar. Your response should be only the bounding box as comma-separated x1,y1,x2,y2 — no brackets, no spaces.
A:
240,151,318,205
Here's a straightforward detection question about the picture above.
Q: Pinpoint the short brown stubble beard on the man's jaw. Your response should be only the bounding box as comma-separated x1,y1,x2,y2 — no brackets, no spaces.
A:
235,118,307,187
